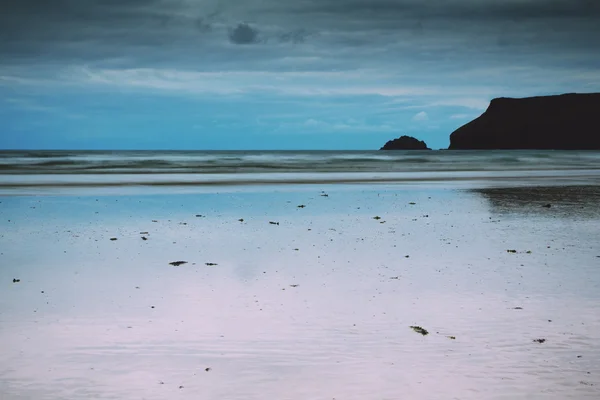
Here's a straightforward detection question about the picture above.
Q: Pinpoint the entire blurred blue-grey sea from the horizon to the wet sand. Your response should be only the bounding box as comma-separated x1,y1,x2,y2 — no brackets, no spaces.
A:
0,150,600,194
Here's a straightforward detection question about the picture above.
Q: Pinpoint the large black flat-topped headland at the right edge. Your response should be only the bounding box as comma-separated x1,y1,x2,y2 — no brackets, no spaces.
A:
449,93,600,150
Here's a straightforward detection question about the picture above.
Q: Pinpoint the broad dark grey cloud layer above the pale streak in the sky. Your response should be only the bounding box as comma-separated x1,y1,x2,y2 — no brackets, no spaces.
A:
0,0,600,83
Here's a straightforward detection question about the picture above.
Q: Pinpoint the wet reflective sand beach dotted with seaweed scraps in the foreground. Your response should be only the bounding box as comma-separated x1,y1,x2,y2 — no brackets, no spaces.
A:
0,185,600,400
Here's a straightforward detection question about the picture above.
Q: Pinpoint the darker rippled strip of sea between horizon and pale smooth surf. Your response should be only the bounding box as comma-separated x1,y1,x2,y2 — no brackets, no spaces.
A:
0,151,600,175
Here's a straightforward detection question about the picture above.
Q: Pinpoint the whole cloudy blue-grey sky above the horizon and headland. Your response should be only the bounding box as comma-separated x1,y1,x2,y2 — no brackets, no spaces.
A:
0,0,600,150
